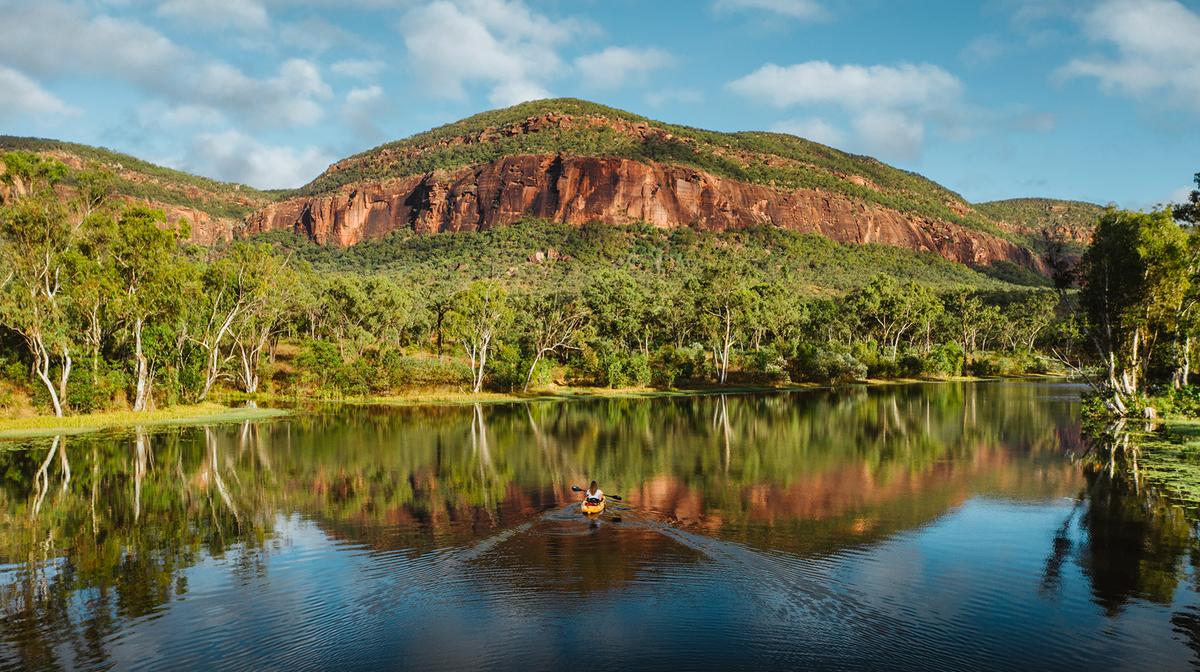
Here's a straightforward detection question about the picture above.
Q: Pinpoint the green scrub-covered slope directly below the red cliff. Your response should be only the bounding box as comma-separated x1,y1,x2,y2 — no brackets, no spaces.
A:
251,220,1022,296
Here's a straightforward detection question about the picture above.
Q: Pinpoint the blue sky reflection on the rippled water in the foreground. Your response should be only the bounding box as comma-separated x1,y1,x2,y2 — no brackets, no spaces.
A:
82,498,1196,670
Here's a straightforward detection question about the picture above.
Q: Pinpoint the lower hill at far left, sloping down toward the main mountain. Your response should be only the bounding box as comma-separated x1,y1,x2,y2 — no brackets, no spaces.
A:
0,136,276,244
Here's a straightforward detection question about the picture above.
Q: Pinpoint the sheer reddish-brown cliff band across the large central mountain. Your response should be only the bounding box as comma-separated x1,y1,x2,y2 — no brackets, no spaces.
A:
245,155,1043,270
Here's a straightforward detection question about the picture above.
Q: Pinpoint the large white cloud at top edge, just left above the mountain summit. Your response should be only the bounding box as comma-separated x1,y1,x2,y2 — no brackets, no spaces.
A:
400,0,582,104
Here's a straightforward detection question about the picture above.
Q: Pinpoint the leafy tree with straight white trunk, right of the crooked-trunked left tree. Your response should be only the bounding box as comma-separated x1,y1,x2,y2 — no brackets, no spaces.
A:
113,205,186,410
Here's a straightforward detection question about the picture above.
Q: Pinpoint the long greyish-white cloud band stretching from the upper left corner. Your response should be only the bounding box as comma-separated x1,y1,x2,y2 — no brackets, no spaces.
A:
0,1,332,126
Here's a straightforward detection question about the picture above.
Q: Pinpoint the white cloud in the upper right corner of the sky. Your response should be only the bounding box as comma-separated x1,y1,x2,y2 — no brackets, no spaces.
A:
1058,0,1200,113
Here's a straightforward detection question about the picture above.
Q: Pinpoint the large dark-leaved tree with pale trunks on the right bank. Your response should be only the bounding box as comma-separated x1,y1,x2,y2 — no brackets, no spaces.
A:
1080,209,1192,414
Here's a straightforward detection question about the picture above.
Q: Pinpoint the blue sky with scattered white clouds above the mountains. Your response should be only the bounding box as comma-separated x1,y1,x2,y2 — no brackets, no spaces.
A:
0,0,1200,209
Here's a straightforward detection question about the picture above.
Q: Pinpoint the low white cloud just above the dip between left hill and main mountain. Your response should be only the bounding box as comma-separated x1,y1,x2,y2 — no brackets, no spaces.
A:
180,131,332,188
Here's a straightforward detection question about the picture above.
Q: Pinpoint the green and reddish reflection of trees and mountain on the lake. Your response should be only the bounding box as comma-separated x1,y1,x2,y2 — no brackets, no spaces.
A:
0,384,1078,661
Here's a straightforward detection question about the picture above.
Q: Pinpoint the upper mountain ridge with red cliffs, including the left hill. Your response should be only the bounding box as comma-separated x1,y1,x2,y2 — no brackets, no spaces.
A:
0,98,1098,272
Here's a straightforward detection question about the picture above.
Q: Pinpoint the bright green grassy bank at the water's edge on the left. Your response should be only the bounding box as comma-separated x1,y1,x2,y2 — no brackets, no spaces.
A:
0,403,289,439
